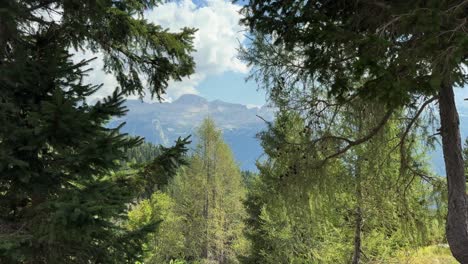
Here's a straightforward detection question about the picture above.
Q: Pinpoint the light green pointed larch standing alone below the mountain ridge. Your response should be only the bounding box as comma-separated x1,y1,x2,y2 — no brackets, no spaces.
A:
169,118,246,263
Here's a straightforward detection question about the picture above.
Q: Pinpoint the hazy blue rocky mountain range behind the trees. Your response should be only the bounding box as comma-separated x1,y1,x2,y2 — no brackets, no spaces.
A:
110,94,274,170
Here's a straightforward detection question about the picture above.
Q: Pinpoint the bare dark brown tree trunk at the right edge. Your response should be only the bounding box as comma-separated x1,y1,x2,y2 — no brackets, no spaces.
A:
439,81,468,264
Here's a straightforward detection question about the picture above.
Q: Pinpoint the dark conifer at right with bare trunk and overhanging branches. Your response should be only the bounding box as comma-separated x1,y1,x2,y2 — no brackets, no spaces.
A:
244,0,468,264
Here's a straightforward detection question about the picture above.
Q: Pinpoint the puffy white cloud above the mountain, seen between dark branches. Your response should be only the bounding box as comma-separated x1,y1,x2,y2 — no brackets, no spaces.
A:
74,0,248,101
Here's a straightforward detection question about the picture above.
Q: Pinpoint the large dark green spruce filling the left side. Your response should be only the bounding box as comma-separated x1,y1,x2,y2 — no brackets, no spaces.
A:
0,0,194,263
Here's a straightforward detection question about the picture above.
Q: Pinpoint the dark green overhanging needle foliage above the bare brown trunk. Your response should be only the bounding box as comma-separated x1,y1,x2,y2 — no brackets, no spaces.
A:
244,0,468,107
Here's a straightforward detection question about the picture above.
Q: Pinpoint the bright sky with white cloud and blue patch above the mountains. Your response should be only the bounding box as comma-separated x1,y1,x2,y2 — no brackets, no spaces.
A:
77,0,468,109
